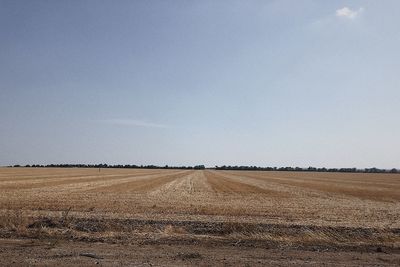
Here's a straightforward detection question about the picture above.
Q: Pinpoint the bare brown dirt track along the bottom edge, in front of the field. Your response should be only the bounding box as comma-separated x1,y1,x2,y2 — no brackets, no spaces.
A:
0,239,400,266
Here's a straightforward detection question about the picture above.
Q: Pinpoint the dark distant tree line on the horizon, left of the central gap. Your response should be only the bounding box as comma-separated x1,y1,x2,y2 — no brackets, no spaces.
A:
13,163,205,170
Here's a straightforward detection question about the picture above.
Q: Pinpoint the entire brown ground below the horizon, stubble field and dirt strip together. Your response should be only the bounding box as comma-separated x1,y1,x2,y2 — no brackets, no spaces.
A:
0,168,400,266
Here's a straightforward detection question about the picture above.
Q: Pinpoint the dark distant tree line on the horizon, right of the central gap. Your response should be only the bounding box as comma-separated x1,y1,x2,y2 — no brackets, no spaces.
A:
214,165,400,173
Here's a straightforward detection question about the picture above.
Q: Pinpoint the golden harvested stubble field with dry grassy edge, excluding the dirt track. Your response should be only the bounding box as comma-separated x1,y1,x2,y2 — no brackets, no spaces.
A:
0,168,400,266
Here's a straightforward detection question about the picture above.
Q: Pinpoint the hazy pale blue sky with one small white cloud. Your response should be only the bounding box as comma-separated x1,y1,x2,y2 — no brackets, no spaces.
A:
0,0,400,168
